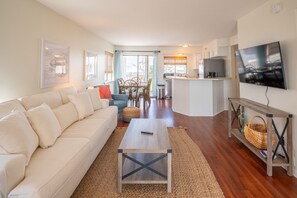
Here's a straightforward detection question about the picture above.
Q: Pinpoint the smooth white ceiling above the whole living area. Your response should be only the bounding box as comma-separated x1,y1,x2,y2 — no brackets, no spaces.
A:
38,0,267,46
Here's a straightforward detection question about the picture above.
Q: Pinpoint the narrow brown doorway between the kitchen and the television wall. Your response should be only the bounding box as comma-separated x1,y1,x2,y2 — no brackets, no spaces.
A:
231,44,240,98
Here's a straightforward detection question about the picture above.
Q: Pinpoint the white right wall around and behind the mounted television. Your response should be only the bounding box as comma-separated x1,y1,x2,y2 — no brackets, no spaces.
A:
238,0,297,176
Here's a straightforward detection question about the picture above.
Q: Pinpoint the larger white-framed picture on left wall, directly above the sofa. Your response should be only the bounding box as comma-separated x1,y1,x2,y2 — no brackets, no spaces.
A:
40,40,70,88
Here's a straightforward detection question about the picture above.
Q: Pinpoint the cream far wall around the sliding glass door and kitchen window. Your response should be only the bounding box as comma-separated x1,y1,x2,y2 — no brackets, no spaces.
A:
116,46,202,84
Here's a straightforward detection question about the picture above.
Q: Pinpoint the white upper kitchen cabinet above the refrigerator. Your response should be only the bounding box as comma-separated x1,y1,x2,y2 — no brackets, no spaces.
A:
203,39,230,58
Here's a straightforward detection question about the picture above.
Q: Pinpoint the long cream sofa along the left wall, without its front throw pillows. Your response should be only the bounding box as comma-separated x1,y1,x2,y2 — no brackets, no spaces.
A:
0,87,118,198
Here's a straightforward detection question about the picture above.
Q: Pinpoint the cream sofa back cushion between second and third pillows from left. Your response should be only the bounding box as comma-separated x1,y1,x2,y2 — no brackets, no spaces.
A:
53,102,78,131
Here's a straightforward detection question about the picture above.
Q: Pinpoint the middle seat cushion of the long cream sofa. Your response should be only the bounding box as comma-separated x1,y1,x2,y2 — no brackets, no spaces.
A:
61,119,109,149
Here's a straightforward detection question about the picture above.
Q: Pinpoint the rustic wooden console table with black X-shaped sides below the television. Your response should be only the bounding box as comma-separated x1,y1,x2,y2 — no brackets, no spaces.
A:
228,98,293,176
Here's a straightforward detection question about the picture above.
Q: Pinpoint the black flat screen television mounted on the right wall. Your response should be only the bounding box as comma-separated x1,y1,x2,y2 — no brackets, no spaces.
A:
235,42,287,89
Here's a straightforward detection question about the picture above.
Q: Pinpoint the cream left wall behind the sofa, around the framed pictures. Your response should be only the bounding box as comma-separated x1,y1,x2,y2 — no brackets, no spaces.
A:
0,0,114,102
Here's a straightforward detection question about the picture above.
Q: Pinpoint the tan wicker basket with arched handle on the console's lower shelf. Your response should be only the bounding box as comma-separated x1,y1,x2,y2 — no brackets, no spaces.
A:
244,116,275,150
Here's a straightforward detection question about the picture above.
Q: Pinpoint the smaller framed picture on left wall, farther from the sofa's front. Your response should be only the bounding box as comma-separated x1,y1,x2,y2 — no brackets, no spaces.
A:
84,50,98,81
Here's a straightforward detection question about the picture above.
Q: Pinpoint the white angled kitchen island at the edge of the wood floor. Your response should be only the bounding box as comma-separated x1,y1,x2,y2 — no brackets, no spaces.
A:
172,78,230,116
